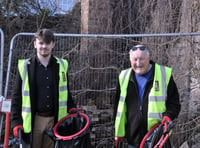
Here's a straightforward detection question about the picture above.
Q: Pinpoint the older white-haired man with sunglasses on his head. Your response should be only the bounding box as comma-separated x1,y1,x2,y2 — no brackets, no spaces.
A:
114,45,180,148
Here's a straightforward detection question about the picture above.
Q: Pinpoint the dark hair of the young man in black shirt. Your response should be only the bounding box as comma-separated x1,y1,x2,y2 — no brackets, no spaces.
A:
34,29,55,44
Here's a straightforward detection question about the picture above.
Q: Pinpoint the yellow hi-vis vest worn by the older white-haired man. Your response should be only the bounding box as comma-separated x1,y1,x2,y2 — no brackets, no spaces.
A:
115,64,172,137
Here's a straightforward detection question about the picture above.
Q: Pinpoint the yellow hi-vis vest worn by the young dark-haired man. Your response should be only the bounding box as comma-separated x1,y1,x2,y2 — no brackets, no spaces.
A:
18,57,68,133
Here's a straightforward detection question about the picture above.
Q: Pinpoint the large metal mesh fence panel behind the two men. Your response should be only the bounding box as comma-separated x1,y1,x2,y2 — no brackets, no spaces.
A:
5,33,200,148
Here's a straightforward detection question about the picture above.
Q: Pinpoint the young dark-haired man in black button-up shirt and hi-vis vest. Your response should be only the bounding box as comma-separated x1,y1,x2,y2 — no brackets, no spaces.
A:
11,29,76,148
